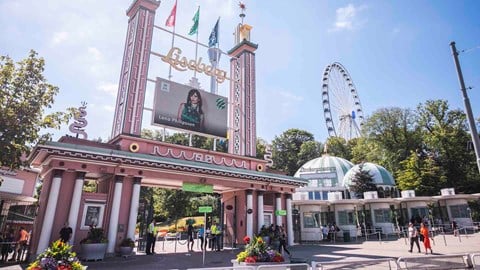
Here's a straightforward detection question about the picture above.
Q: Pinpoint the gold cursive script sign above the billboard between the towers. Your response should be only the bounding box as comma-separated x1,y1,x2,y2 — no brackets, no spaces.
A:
161,47,230,83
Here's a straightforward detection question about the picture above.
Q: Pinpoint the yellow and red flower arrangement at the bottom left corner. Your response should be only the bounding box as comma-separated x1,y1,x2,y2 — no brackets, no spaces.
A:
27,240,85,270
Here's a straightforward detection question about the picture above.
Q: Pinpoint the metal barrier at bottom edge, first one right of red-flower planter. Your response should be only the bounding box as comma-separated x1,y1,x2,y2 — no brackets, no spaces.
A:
311,258,399,270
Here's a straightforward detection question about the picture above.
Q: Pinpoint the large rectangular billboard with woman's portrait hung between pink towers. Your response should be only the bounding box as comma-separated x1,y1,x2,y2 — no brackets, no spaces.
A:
152,78,228,138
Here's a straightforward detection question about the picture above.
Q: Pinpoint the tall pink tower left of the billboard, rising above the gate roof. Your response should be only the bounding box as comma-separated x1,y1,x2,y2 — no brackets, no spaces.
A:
112,0,160,138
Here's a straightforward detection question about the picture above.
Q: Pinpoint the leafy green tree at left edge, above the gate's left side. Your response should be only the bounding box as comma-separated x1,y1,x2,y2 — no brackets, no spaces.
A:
0,50,75,169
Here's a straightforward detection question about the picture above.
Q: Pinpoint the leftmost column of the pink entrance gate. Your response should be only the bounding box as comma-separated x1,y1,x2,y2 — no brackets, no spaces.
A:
36,170,63,255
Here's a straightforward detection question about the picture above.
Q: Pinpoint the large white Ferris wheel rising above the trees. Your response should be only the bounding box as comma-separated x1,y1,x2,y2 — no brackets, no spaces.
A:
322,62,363,141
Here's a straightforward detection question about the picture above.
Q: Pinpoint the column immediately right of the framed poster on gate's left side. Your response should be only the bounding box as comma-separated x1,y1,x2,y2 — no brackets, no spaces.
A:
107,175,123,253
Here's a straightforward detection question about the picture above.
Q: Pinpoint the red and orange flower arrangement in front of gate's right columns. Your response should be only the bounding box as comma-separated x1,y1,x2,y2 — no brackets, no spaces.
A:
237,236,285,263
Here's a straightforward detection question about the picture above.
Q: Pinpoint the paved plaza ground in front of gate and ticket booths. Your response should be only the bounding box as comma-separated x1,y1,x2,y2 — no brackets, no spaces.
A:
0,233,480,270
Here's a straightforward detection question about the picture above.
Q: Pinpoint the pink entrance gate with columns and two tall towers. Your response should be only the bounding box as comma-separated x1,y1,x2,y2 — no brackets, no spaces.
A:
30,0,306,254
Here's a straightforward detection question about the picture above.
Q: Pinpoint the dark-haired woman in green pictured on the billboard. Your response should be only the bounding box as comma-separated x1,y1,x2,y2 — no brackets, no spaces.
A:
177,89,204,131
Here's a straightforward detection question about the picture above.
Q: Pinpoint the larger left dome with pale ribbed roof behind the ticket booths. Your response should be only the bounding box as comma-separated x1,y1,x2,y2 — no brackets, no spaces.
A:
295,154,353,187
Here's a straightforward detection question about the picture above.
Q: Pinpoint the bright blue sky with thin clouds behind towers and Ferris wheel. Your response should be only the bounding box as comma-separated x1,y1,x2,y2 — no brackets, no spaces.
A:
0,0,480,142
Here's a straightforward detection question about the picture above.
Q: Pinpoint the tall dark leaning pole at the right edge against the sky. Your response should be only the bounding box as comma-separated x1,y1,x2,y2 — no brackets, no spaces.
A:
450,41,480,172
